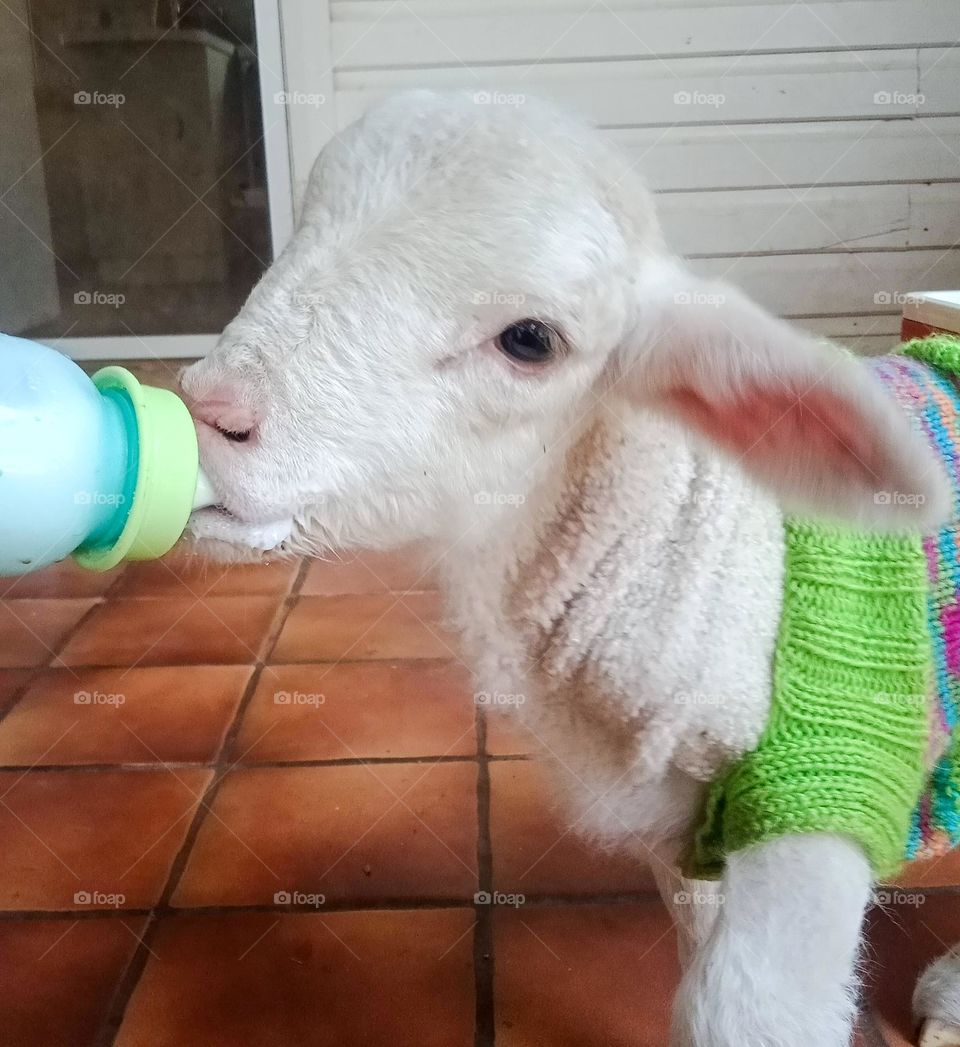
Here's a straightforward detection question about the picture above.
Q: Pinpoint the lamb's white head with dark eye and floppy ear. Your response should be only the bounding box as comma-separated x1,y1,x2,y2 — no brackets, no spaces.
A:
183,92,943,550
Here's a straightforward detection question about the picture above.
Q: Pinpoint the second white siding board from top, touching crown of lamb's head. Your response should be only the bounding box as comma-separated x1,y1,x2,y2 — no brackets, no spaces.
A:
334,49,960,127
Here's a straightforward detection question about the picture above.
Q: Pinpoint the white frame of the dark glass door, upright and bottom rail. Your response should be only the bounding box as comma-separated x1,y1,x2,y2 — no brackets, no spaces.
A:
42,0,293,360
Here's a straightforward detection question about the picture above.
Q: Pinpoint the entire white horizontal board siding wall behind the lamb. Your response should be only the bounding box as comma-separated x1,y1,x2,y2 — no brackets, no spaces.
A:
284,0,960,337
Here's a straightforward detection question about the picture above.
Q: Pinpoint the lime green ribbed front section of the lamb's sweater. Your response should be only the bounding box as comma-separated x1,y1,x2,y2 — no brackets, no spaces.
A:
687,520,931,878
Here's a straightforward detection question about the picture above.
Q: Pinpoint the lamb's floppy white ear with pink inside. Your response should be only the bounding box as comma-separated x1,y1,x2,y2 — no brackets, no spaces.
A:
613,266,952,528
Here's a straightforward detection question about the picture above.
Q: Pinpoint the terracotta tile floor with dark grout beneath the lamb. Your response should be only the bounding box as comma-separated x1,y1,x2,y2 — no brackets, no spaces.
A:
0,554,960,1047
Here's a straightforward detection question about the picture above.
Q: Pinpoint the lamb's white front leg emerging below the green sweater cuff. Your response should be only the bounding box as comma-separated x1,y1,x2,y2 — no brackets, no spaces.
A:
671,833,871,1047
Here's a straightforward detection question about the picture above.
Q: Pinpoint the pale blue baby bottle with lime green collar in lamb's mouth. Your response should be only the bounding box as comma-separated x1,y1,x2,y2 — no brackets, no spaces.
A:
0,334,218,575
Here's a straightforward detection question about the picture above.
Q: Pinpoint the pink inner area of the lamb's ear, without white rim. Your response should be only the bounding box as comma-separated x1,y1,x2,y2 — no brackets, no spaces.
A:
668,385,890,488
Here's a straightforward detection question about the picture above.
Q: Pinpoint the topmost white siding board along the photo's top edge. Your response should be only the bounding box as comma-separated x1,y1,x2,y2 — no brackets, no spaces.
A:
332,0,960,70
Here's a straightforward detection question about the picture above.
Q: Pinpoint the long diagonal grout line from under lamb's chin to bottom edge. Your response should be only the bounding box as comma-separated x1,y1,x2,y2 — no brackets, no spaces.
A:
88,559,309,1047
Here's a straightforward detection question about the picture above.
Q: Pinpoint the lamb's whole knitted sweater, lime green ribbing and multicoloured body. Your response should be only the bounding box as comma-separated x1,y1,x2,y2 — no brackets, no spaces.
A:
685,336,960,878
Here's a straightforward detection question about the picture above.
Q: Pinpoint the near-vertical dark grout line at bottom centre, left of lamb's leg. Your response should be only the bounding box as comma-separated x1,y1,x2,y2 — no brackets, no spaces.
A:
473,707,496,1047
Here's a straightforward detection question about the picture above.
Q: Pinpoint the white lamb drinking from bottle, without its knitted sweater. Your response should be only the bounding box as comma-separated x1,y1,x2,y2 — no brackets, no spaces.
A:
182,91,960,1047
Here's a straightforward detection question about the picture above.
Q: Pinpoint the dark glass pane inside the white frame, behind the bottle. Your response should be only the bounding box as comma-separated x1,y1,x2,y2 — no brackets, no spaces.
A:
0,0,270,338
